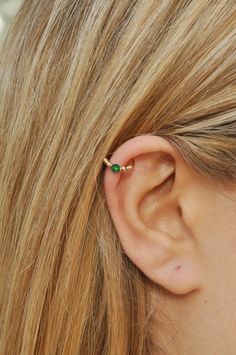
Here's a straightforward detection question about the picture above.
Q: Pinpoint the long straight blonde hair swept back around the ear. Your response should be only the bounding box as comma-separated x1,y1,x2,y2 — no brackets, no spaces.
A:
0,0,236,355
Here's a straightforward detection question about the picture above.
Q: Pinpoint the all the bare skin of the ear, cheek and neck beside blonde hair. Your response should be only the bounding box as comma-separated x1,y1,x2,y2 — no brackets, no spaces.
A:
104,135,236,355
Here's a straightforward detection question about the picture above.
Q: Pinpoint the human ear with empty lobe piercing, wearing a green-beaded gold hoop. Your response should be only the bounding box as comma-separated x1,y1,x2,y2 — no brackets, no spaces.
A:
104,134,202,294
